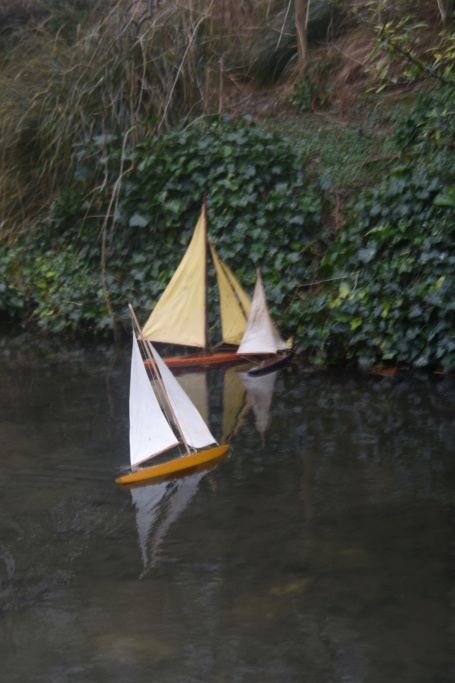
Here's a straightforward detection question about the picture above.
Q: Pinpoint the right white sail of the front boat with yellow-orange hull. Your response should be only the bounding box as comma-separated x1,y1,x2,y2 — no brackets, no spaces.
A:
148,342,216,448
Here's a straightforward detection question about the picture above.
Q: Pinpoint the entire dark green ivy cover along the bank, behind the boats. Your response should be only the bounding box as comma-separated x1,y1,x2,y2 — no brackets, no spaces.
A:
0,87,455,371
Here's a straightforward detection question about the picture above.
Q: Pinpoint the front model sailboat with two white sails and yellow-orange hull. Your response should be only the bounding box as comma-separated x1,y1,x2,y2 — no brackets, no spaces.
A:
116,306,229,484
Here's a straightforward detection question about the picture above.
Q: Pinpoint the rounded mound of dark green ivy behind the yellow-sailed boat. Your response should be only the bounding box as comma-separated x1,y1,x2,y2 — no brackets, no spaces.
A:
0,120,328,333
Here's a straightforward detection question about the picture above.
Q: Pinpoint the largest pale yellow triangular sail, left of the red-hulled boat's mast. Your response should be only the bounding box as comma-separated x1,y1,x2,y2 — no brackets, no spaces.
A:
143,206,207,348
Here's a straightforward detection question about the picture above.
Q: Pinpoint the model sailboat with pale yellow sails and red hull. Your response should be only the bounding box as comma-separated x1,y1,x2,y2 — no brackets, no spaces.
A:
143,202,251,367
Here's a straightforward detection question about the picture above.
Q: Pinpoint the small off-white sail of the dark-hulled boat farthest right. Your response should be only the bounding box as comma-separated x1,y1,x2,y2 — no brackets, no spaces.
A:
237,268,288,355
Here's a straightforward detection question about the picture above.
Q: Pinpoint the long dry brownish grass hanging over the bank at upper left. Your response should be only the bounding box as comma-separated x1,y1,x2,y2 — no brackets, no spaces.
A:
0,1,246,235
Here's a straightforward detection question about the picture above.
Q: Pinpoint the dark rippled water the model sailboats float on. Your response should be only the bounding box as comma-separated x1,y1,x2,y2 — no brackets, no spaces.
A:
0,337,455,683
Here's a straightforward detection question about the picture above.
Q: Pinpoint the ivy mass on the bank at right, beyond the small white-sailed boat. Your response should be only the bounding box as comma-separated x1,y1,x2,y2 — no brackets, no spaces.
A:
292,85,455,370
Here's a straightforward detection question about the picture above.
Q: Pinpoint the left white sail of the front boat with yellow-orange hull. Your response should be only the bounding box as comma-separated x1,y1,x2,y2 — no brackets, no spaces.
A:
130,334,179,465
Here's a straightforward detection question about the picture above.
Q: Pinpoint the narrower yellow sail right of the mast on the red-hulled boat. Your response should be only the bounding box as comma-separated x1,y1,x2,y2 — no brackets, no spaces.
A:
210,244,251,346
